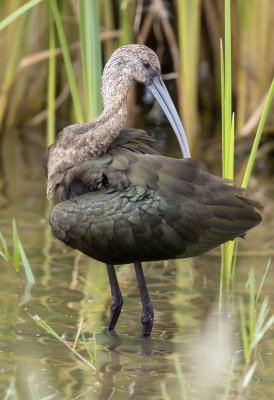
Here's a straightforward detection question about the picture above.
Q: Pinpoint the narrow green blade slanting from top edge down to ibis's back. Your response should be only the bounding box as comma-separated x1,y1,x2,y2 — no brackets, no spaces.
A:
49,0,83,122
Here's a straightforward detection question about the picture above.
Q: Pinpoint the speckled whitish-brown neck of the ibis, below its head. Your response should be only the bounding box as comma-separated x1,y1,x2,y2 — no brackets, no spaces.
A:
86,77,133,156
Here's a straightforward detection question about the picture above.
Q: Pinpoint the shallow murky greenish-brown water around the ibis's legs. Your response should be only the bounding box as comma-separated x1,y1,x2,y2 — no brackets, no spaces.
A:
0,132,274,400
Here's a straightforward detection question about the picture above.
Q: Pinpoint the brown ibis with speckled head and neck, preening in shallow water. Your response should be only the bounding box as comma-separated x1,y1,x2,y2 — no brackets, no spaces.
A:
43,44,262,337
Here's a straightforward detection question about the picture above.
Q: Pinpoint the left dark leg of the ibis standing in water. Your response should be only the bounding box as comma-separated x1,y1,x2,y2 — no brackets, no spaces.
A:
107,264,123,331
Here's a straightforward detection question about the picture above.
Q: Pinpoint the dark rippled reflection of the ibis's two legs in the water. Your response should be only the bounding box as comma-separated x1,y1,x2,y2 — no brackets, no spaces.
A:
99,330,154,400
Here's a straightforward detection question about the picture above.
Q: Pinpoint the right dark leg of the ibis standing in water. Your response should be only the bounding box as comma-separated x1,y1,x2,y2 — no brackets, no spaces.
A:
134,262,154,337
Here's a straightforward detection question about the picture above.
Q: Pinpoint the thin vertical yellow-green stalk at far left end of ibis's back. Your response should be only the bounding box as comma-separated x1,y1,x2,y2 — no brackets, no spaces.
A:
47,15,56,146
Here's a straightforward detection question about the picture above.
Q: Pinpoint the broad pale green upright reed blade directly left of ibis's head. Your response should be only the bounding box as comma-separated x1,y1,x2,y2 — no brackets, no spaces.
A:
79,0,102,120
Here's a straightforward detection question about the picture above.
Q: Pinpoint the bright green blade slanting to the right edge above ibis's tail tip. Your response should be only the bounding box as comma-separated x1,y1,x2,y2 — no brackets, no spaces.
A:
242,79,274,188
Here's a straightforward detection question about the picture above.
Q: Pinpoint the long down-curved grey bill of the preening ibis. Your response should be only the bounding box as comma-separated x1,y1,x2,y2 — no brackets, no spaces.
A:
147,75,191,158
